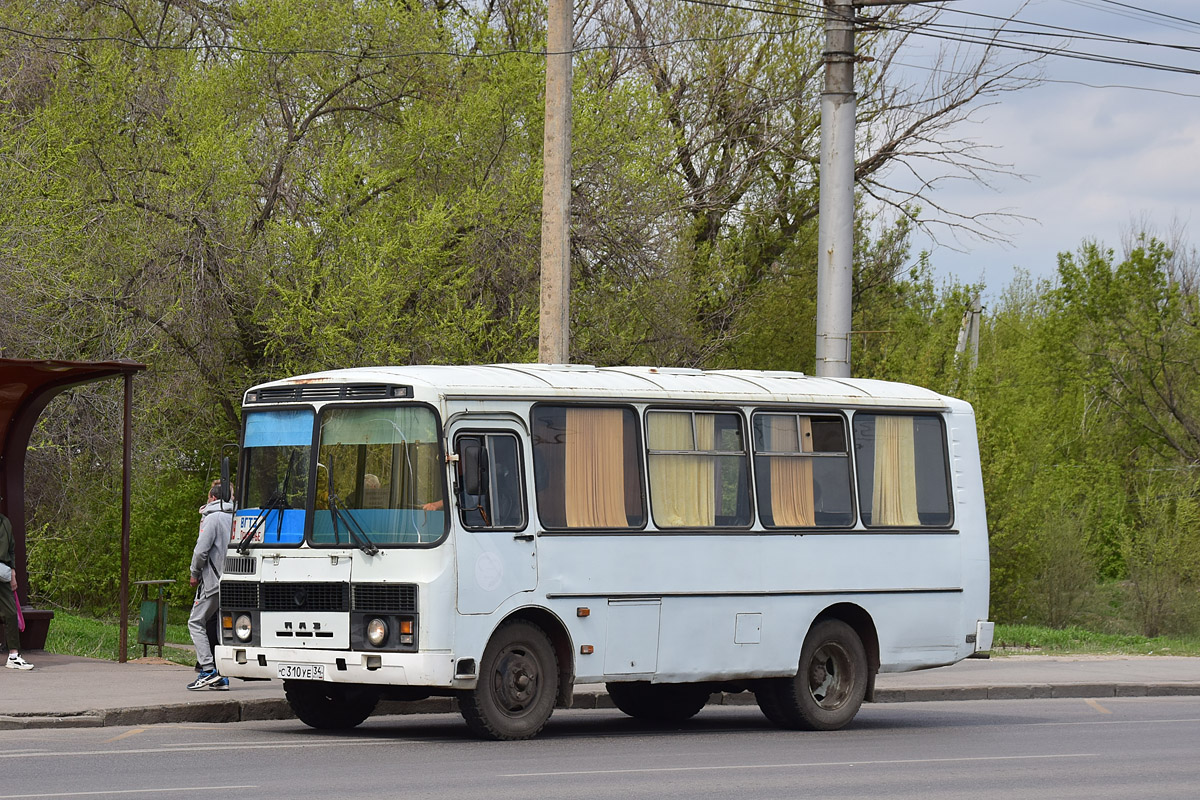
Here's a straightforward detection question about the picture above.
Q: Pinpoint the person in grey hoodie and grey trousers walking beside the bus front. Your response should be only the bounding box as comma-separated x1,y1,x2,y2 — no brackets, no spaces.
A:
187,481,233,690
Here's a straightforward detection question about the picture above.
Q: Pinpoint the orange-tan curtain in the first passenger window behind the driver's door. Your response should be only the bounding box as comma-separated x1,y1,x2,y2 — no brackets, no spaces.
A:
564,408,629,528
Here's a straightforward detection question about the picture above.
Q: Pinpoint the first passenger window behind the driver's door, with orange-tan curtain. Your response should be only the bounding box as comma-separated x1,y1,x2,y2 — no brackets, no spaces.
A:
533,405,646,529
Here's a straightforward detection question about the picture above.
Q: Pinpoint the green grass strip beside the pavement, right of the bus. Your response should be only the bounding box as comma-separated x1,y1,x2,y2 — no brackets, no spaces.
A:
992,625,1200,656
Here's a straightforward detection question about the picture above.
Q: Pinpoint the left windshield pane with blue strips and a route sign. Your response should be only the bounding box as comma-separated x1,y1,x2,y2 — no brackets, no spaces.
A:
235,409,313,546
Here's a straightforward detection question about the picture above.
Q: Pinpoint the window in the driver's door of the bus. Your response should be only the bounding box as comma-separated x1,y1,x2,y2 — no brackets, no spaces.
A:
455,433,526,530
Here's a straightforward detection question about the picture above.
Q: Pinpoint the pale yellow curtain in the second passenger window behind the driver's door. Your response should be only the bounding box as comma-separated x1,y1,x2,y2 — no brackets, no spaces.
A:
647,411,716,528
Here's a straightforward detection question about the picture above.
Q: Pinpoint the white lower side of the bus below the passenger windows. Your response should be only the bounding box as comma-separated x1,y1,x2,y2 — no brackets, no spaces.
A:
539,533,973,681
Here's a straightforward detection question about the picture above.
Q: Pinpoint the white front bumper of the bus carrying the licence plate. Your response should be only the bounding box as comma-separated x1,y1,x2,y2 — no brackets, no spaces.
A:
216,645,463,688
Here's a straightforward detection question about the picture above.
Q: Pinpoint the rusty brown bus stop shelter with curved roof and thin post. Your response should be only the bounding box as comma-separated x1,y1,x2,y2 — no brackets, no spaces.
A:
0,359,146,661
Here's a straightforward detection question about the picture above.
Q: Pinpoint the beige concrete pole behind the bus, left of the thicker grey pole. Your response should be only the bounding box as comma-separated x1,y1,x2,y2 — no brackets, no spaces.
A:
538,0,574,363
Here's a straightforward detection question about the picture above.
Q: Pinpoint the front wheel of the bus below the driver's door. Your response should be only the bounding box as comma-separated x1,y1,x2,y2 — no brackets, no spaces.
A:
458,621,558,740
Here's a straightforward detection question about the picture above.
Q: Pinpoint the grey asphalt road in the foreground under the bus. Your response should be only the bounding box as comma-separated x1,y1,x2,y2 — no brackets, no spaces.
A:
0,697,1200,800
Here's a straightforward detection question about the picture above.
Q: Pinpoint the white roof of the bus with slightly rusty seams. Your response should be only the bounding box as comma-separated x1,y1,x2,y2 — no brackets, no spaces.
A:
247,363,955,408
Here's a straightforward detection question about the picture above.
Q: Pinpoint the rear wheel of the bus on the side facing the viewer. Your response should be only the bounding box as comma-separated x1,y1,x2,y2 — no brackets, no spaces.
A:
756,619,868,730
